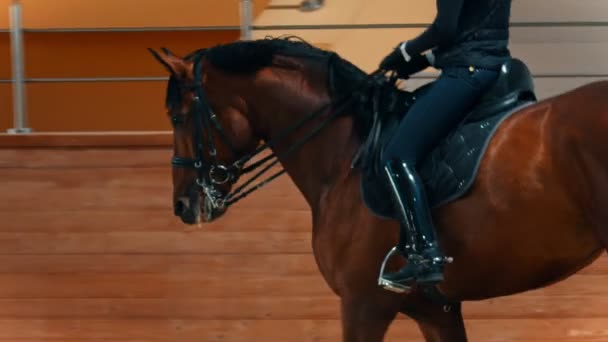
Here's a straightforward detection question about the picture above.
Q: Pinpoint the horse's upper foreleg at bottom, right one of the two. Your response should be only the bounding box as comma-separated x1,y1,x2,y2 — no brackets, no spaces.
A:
402,296,467,342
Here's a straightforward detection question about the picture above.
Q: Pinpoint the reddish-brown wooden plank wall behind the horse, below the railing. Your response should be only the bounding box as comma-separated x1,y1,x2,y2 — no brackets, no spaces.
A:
0,135,608,342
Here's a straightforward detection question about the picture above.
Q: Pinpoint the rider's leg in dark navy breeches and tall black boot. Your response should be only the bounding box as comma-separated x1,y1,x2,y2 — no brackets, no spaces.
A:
383,68,498,287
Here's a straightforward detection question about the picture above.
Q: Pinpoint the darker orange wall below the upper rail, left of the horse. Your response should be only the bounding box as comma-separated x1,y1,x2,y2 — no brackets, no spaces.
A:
0,31,239,131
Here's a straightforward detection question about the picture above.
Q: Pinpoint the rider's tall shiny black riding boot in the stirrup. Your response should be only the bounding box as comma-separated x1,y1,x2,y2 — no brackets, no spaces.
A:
382,160,445,287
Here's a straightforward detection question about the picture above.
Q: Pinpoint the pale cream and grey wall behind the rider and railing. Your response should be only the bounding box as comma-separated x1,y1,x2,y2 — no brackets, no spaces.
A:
254,0,608,97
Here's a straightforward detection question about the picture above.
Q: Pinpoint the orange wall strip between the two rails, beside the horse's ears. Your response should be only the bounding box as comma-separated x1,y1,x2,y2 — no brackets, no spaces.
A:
25,30,240,77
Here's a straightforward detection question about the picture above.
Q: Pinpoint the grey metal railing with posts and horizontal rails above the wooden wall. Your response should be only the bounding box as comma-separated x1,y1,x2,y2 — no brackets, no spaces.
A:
0,0,608,134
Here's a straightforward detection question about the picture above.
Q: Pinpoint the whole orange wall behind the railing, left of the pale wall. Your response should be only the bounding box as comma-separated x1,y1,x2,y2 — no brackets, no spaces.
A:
0,0,268,132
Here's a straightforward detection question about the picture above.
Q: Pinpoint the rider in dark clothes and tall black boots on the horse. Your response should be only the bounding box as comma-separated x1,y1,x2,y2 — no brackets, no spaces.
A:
380,0,511,290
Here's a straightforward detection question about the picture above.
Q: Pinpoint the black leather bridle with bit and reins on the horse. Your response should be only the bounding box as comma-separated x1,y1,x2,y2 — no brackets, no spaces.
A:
171,50,382,214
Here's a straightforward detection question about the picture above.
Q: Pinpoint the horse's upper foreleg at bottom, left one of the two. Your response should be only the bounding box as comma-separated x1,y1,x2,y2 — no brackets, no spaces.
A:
342,296,399,342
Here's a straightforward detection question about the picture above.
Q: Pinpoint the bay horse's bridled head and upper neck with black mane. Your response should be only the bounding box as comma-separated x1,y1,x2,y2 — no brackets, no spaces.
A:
150,38,380,224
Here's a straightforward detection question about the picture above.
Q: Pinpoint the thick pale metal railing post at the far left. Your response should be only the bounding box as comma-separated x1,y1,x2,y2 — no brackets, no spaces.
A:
8,1,32,133
